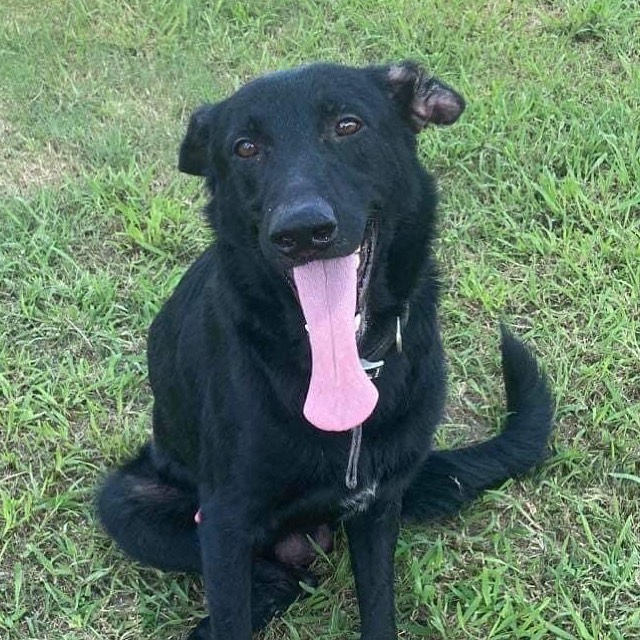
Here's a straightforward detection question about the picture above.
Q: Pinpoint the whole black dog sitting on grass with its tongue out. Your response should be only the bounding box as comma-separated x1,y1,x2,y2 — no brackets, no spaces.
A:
98,63,553,640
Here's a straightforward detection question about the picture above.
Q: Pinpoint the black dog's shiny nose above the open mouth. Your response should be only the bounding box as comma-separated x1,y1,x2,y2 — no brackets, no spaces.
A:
269,200,338,259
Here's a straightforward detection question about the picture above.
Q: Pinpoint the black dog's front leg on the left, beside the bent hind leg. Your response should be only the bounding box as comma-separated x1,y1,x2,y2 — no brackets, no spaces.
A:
198,492,253,640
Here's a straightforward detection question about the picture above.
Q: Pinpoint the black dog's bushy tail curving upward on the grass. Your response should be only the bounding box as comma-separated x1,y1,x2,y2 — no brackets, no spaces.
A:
402,326,554,522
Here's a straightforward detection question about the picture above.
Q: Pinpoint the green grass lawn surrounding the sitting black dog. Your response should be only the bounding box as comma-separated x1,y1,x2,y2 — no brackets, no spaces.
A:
0,0,640,640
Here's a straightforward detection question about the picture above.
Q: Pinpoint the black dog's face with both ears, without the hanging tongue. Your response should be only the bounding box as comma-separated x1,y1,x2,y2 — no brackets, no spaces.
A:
179,63,464,271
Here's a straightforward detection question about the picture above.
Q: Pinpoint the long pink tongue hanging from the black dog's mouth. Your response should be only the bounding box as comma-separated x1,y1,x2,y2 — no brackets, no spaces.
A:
293,255,378,431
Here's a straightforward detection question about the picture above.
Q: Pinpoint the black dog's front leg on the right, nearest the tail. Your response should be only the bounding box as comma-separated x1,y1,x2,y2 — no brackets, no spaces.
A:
346,501,400,640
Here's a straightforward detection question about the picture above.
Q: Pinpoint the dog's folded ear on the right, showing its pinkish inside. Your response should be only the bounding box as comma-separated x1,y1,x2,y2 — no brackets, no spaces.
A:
387,61,465,133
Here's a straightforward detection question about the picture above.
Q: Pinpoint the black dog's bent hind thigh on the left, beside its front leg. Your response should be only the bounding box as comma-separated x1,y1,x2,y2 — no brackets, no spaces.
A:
97,444,201,572
